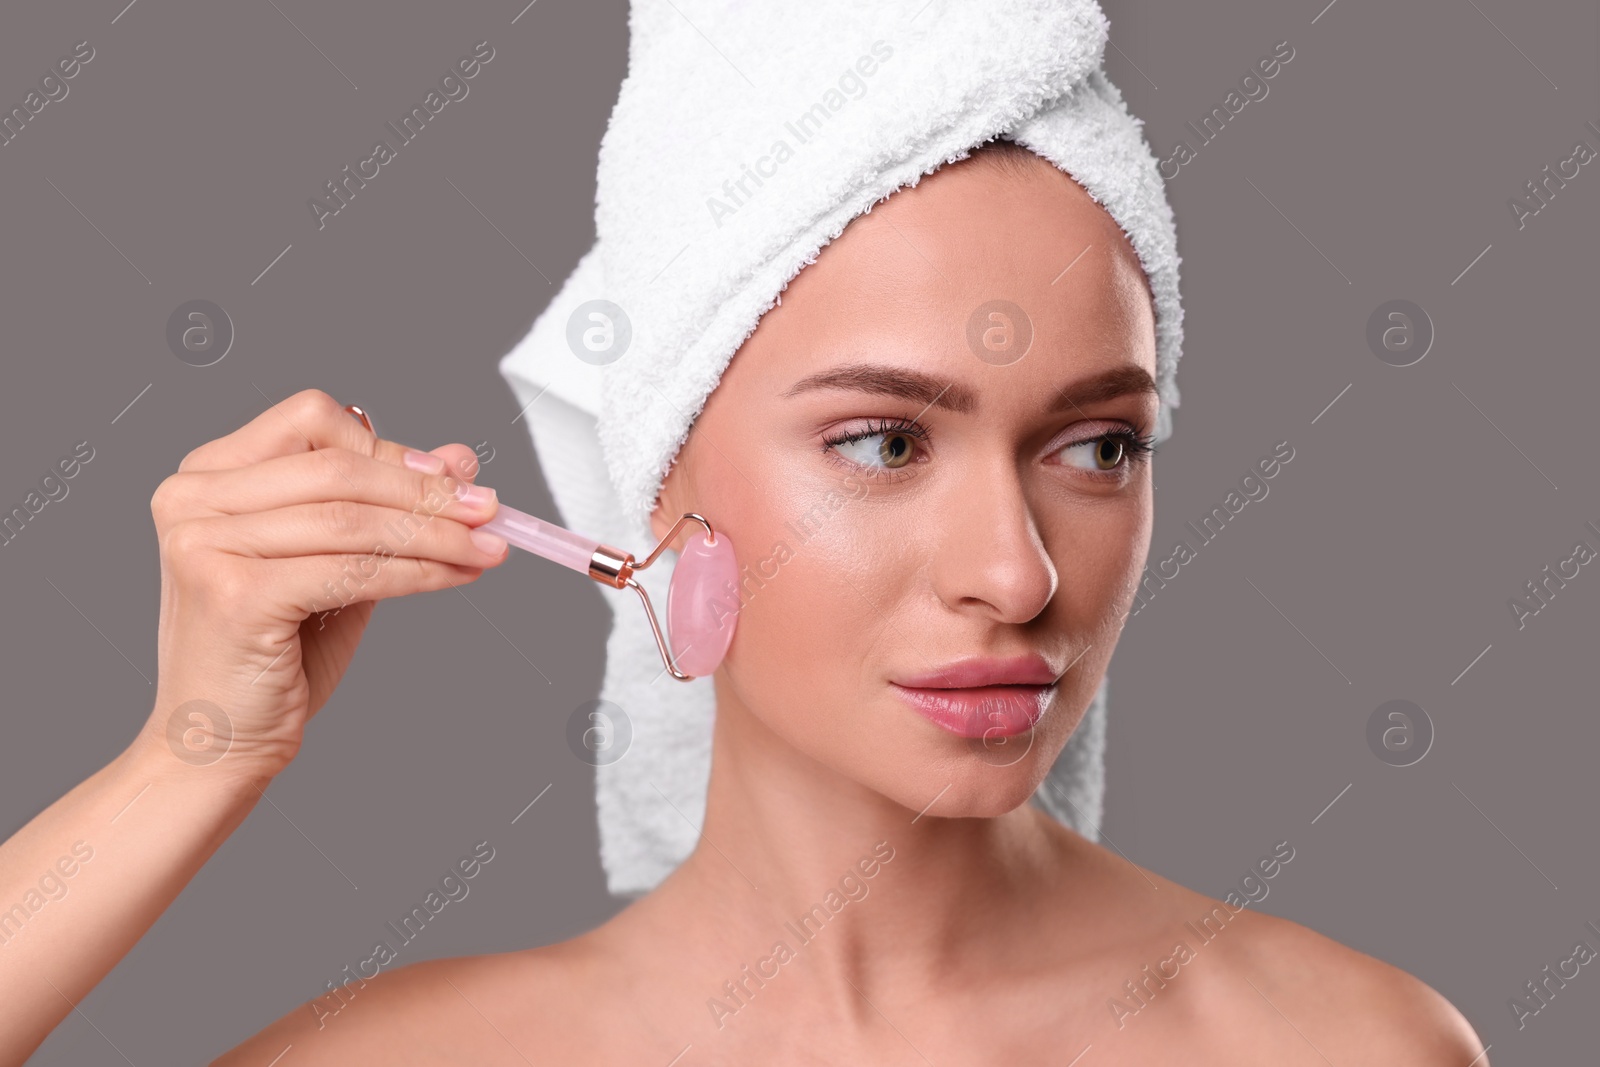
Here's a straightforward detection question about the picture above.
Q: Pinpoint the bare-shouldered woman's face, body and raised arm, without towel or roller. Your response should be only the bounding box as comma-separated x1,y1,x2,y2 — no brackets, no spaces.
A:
0,142,1488,1067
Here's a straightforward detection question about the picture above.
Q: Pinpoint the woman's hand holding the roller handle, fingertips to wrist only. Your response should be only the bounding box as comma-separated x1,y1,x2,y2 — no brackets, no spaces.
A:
144,389,506,779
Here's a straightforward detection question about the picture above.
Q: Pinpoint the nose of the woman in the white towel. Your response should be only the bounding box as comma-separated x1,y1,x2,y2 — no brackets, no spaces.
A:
931,462,1058,622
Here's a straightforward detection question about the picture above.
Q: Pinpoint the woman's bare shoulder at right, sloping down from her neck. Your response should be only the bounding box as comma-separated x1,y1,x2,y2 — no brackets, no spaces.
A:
1017,821,1490,1067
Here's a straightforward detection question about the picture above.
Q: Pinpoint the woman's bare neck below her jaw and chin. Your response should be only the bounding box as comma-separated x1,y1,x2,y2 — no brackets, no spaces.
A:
662,693,1066,1001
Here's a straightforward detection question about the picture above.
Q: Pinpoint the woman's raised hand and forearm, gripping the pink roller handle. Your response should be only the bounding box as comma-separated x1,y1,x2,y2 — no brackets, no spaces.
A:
0,389,506,1065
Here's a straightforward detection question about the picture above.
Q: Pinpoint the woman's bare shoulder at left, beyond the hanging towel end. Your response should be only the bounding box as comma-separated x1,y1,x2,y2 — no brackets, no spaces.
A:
211,944,582,1067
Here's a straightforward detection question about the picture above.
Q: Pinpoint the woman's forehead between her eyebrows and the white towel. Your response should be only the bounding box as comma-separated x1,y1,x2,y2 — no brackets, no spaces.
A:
730,162,1155,394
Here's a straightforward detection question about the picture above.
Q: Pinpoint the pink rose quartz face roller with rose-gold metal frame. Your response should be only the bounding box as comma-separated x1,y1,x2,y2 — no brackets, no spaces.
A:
478,504,739,681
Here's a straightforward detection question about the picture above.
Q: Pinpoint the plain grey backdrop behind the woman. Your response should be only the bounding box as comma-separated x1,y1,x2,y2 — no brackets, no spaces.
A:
0,0,1600,1065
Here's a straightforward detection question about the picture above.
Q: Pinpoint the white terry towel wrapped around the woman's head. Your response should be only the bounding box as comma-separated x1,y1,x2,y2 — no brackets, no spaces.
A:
501,0,1182,896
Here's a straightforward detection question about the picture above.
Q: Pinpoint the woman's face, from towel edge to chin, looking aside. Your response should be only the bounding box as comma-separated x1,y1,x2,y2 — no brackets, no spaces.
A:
653,157,1157,816
